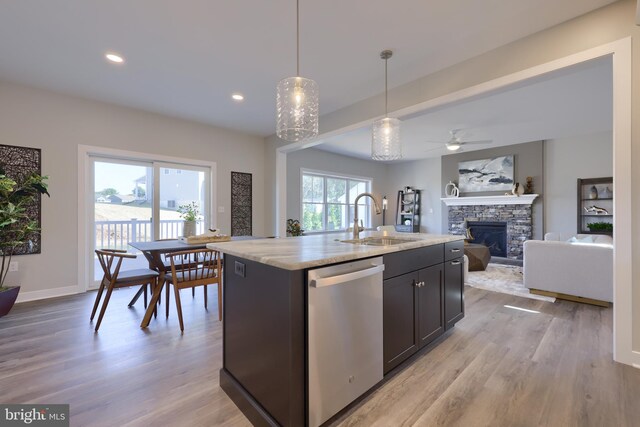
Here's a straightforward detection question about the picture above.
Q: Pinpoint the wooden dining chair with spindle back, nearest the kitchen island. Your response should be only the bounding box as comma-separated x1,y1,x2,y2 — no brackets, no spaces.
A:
166,249,222,331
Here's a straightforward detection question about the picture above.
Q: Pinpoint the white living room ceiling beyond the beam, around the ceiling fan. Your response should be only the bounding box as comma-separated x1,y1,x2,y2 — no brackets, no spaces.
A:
315,58,613,163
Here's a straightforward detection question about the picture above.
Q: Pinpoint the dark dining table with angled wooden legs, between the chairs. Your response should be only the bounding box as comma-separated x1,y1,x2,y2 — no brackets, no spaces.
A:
128,236,260,328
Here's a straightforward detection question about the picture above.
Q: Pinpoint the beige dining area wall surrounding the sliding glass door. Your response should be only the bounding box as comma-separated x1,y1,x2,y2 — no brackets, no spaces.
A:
0,82,265,300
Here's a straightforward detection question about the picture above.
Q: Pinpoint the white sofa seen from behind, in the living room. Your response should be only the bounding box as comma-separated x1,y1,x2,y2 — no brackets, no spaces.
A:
523,233,613,302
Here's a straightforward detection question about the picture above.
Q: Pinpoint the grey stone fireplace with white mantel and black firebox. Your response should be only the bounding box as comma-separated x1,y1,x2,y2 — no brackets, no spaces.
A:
442,194,538,260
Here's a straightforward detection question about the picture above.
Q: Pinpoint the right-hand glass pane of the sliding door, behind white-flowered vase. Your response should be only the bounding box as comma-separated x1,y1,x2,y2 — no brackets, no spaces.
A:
158,168,206,239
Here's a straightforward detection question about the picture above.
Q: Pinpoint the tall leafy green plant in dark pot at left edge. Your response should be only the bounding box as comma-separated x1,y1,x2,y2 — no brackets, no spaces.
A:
0,166,49,317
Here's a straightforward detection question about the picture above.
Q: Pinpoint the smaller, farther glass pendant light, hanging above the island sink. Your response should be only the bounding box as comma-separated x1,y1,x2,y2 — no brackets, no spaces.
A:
371,50,402,160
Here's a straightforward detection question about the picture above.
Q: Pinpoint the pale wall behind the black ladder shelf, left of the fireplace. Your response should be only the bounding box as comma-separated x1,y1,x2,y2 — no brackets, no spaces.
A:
387,157,447,234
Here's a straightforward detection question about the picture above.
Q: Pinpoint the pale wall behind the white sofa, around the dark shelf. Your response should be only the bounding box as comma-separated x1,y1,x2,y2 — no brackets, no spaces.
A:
544,132,613,236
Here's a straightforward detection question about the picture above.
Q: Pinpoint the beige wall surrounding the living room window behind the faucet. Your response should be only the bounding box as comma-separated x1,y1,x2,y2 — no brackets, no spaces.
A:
287,148,388,232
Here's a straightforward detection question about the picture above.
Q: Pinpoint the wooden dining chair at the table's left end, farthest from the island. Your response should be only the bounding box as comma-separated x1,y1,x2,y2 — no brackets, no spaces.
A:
90,249,158,332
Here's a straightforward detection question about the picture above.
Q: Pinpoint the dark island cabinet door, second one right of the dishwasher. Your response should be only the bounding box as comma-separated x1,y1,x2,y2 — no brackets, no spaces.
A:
418,264,444,347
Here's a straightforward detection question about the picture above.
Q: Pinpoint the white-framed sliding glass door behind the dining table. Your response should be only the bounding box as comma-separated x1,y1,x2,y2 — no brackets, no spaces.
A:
87,156,211,287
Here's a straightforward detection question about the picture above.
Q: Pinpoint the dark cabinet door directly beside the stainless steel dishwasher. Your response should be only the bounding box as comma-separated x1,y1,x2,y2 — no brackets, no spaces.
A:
382,272,418,374
